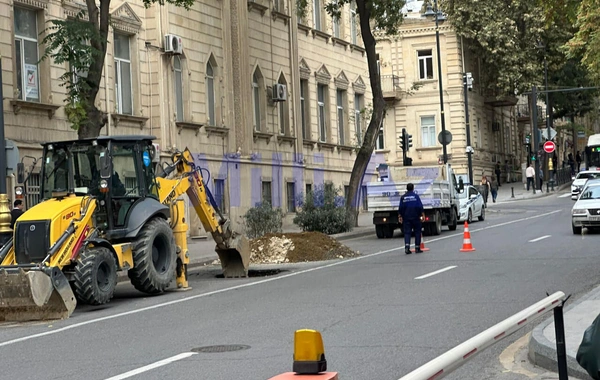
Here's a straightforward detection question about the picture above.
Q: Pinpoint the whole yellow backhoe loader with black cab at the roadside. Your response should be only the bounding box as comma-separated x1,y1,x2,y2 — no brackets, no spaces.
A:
0,136,250,321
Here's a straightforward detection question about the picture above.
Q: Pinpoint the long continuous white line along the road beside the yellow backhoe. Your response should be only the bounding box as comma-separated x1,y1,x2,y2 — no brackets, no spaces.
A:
0,210,562,347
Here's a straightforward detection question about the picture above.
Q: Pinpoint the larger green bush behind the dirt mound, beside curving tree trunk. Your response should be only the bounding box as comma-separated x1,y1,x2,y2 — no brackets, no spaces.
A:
294,186,352,235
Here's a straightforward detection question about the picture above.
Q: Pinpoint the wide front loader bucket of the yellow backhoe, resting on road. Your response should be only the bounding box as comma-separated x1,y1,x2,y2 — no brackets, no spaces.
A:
0,268,77,322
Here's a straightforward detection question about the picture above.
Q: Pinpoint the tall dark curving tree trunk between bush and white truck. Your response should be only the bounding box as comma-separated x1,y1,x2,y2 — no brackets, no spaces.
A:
346,0,385,226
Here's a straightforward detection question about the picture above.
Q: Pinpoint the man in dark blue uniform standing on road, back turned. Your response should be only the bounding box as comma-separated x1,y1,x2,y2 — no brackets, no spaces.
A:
398,183,425,255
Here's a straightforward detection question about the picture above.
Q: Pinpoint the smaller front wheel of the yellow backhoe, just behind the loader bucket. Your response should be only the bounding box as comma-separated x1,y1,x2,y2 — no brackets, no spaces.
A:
73,247,117,305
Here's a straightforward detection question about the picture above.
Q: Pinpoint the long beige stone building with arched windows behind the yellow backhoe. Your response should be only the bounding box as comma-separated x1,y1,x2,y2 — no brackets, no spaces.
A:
0,0,371,235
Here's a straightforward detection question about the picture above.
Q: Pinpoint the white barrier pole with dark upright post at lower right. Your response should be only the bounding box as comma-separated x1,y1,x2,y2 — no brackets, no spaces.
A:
399,292,568,380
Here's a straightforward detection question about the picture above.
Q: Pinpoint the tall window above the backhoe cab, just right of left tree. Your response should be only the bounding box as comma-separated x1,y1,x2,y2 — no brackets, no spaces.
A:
114,33,133,115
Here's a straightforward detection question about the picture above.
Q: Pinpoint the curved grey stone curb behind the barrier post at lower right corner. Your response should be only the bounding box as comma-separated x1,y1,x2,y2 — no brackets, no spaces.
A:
527,286,600,380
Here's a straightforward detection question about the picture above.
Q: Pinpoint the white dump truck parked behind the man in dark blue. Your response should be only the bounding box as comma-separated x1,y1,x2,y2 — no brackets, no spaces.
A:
367,164,464,239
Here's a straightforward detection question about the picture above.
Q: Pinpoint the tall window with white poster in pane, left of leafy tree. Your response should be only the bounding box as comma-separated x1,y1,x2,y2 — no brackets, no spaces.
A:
14,7,40,102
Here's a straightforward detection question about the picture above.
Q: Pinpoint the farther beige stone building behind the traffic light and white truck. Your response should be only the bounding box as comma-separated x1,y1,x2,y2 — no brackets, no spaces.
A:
377,5,523,184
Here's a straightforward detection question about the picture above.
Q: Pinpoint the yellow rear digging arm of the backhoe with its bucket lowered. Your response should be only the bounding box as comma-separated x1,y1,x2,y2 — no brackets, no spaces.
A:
157,148,250,278
